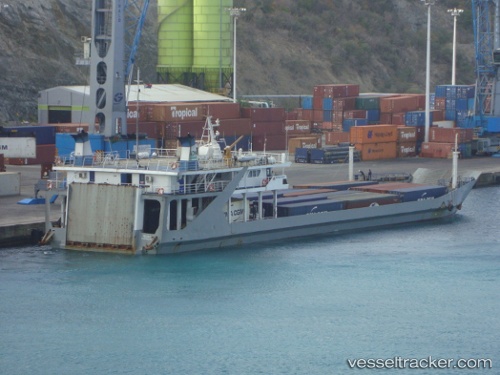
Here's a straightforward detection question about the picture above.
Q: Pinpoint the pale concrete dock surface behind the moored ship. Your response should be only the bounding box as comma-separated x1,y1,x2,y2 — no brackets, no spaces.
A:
0,157,500,247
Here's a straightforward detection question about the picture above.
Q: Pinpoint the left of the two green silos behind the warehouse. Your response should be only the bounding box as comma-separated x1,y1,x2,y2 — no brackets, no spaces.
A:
157,0,193,83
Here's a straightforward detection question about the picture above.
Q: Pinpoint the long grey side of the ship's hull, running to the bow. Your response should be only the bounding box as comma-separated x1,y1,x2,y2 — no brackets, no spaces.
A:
151,181,474,254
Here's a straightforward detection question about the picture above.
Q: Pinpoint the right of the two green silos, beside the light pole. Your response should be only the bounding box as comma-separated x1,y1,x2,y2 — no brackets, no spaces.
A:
192,0,233,91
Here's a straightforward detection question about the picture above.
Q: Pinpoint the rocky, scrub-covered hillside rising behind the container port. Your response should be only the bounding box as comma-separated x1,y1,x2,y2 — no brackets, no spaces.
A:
0,0,474,124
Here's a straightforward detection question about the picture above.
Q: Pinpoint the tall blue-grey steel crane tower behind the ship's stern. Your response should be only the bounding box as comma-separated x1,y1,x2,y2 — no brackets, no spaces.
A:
89,0,149,137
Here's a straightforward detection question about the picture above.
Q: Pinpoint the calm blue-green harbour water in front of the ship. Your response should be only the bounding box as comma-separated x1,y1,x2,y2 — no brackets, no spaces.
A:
0,188,500,375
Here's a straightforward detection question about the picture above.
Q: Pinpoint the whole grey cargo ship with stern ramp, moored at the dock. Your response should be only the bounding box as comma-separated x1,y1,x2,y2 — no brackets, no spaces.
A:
41,116,475,255
